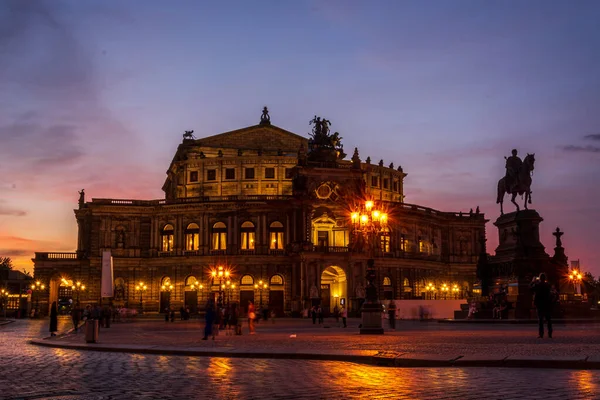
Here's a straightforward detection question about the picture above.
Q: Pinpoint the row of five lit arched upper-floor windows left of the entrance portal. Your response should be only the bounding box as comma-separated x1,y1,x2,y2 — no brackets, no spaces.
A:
160,221,284,251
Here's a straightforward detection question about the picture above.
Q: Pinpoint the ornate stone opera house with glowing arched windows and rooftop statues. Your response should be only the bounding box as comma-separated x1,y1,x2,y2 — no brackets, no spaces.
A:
34,108,486,315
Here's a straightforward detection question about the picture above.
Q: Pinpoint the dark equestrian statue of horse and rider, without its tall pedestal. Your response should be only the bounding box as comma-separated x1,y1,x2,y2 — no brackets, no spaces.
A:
496,149,535,214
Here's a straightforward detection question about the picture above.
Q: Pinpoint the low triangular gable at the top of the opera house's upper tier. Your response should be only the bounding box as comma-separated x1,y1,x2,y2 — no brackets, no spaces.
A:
195,125,308,152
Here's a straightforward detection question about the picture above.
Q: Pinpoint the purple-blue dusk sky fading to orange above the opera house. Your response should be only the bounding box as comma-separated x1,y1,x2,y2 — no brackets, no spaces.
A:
0,0,600,275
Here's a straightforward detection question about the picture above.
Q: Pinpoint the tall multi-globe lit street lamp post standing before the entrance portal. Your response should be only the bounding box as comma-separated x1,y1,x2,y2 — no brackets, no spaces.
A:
351,200,388,334
